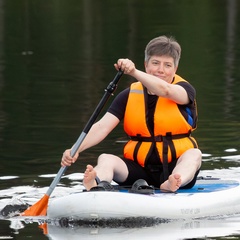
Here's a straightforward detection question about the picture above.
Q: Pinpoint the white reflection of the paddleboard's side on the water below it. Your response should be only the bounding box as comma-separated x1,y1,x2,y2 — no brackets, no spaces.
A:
47,217,240,240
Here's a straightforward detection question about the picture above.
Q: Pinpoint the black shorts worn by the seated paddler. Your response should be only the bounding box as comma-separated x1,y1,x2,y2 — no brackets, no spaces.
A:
115,159,199,189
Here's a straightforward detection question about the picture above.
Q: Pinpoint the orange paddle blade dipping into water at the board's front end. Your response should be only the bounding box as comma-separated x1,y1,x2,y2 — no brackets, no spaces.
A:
21,194,49,216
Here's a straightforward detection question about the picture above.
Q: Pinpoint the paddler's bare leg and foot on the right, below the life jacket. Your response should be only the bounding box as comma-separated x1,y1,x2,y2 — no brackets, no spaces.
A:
160,148,202,192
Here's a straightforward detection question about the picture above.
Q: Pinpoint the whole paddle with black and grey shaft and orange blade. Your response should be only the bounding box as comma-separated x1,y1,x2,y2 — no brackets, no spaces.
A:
21,70,123,216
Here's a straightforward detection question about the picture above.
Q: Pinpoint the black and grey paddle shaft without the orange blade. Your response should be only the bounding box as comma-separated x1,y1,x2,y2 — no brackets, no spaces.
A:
46,71,123,196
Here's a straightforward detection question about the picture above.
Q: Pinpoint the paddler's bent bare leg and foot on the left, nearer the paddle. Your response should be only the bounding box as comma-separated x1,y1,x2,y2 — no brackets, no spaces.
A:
83,154,128,190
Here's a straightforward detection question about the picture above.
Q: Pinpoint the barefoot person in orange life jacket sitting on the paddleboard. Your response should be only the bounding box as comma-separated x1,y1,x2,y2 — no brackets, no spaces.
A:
61,36,202,192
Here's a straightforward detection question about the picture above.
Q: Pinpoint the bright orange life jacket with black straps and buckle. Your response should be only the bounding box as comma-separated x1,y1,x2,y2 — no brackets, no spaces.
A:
124,75,197,170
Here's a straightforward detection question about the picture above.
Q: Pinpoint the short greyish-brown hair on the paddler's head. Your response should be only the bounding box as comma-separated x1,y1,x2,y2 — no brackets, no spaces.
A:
145,36,181,66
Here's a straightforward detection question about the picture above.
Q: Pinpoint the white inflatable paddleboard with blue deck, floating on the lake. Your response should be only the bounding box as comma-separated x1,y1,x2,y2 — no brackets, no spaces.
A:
47,178,240,220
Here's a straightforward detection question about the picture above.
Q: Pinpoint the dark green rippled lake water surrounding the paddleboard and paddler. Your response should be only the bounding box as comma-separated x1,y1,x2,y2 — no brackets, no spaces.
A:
0,0,240,239
